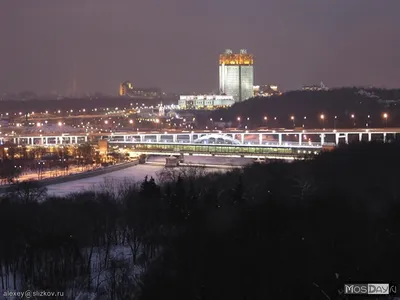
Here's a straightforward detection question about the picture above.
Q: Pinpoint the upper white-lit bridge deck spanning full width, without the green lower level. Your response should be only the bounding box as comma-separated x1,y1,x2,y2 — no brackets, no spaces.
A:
0,128,400,147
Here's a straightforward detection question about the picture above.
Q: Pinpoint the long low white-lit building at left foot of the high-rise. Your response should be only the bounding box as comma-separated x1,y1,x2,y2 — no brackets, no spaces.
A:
178,95,235,109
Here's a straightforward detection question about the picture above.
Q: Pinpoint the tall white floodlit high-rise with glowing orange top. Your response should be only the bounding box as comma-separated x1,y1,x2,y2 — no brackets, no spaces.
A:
219,49,254,102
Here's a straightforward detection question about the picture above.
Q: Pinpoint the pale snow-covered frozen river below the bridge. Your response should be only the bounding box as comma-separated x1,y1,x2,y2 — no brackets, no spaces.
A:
47,156,253,197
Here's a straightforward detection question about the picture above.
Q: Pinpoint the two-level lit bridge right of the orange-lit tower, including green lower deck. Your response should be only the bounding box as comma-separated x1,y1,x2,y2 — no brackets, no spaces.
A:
104,129,400,159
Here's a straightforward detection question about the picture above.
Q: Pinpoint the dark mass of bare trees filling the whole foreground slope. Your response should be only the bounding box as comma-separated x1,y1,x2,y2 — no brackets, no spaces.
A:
0,144,400,300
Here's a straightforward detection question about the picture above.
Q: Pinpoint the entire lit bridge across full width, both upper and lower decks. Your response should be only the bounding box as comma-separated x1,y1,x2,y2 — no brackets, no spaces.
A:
0,128,400,156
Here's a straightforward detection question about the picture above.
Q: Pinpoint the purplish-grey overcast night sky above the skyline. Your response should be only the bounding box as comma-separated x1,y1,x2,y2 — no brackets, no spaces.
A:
0,0,400,94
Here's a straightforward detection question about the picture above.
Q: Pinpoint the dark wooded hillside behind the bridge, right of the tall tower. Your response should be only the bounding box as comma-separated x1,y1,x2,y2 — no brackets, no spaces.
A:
211,88,400,127
